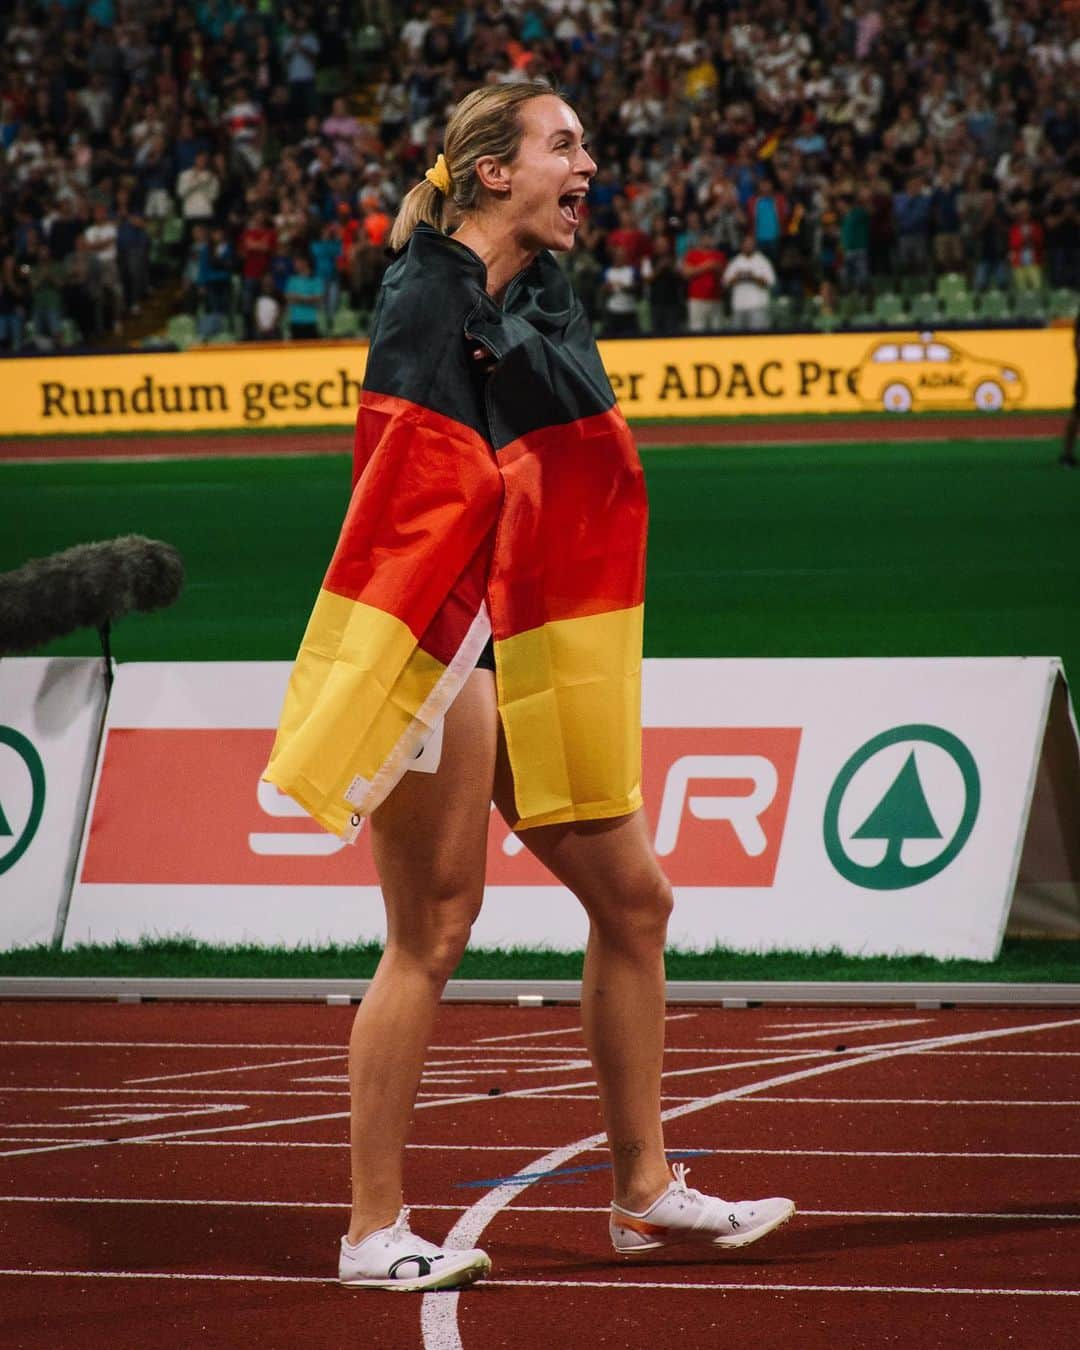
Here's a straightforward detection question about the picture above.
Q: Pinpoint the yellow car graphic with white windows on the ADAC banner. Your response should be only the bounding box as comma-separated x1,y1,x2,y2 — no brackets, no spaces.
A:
859,333,1025,413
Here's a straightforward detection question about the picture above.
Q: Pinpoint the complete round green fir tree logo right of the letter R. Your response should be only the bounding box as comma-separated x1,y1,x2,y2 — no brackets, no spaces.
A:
824,724,980,891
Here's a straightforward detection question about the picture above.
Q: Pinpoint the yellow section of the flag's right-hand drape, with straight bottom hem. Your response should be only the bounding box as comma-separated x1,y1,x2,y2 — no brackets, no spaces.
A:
495,605,644,829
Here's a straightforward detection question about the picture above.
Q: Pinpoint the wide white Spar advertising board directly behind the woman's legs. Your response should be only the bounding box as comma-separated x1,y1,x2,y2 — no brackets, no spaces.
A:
65,659,1076,959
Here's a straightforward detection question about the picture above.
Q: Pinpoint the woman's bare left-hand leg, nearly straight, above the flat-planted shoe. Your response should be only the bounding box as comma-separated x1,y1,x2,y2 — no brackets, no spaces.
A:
347,671,497,1242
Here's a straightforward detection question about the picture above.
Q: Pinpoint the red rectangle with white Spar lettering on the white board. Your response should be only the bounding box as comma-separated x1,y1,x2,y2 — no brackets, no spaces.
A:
78,726,801,887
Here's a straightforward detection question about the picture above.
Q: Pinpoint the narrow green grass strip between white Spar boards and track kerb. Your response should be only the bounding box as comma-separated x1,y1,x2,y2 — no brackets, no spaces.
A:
0,937,1080,984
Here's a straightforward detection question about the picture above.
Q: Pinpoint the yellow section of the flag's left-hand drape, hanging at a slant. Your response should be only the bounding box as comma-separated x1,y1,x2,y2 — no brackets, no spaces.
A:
263,590,446,834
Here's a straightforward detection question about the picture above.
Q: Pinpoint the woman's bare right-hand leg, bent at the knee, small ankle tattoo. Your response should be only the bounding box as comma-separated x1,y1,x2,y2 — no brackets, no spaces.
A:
495,745,671,1211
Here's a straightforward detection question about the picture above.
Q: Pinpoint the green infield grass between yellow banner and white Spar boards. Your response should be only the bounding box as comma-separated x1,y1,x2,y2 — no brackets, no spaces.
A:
0,439,1080,685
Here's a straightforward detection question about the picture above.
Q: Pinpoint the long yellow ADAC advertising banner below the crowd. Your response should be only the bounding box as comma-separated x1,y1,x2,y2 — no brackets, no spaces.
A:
0,328,1073,436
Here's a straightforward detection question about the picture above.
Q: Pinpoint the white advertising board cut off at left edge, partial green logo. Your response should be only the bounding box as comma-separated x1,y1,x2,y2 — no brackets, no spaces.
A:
0,657,105,949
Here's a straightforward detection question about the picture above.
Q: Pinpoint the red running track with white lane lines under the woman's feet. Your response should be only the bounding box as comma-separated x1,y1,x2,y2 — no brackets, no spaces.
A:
0,1003,1080,1350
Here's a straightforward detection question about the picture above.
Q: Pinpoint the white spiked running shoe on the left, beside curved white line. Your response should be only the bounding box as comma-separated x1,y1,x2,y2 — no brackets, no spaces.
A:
338,1210,491,1293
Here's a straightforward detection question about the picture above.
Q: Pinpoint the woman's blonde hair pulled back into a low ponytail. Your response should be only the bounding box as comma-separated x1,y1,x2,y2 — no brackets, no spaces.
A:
387,80,558,250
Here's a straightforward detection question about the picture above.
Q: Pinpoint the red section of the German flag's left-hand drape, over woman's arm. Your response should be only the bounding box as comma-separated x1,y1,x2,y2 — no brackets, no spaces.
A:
324,393,502,639
